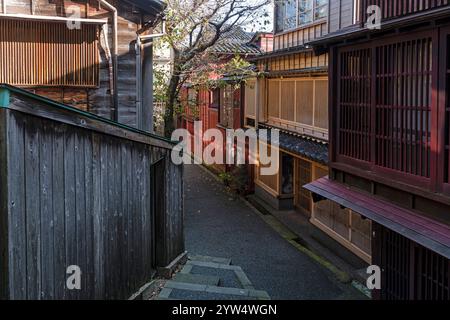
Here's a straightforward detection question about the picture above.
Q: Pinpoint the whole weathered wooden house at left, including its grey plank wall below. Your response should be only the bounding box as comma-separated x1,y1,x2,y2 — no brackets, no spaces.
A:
0,0,184,300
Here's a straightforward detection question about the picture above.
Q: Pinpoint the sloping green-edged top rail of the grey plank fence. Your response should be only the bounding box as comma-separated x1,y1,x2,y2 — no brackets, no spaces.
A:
0,84,176,149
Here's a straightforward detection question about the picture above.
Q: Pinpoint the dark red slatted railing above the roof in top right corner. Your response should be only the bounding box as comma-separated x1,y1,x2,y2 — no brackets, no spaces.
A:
360,0,450,25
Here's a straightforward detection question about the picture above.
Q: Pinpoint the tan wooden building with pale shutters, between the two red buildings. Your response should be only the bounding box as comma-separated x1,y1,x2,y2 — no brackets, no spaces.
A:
244,0,371,263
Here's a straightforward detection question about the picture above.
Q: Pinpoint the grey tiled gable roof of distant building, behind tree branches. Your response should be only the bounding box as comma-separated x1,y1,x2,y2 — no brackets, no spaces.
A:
211,27,261,55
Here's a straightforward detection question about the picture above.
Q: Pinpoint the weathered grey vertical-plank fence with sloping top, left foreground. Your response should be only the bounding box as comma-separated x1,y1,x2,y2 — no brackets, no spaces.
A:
0,86,184,299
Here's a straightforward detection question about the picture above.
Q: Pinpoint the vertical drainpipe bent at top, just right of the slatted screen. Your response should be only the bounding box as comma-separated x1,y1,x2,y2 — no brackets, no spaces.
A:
99,0,119,121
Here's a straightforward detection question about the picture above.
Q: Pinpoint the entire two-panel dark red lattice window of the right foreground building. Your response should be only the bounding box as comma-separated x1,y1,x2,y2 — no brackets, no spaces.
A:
336,32,443,189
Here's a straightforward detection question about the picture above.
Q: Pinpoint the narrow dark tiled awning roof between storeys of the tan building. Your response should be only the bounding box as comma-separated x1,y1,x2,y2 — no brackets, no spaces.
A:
258,126,328,165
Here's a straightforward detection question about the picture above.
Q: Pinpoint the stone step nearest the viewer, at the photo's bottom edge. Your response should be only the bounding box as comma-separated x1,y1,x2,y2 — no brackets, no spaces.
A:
158,280,270,300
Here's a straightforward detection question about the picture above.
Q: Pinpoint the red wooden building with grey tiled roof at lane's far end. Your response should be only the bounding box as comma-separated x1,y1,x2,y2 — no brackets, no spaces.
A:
178,27,273,182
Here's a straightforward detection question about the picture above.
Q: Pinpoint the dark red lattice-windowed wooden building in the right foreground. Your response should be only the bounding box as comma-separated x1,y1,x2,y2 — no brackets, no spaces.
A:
306,0,450,300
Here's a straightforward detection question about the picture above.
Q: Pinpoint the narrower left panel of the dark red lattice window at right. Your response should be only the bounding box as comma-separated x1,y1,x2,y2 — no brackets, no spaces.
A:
338,49,372,161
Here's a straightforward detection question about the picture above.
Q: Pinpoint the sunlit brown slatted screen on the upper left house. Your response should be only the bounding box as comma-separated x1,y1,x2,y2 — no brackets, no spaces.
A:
0,19,99,87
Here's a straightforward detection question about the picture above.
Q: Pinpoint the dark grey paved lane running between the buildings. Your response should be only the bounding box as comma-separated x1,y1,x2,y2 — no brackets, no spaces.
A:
185,165,365,299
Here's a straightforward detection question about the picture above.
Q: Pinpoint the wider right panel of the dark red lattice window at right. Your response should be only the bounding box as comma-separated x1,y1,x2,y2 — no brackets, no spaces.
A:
375,38,432,178
